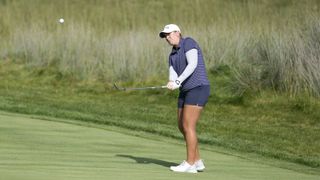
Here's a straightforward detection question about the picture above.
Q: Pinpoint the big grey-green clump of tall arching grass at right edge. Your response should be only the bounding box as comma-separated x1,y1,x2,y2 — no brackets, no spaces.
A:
225,17,320,96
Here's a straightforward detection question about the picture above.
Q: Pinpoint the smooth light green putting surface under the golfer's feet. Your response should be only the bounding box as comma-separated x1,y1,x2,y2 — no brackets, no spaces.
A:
0,114,320,180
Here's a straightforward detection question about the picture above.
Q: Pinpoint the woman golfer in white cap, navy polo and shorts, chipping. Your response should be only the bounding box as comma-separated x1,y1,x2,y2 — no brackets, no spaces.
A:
159,24,210,173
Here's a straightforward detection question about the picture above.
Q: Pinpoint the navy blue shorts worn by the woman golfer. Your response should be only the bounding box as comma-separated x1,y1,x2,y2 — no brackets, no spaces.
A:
178,85,210,108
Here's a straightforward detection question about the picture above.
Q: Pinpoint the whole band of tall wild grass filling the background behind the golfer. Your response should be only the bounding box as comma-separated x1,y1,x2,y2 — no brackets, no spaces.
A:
0,0,320,96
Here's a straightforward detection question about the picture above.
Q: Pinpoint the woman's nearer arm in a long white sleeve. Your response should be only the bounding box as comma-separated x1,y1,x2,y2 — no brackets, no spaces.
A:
177,49,198,83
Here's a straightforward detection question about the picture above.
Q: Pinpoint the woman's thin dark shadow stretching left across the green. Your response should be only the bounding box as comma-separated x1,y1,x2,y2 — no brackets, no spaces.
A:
116,154,178,167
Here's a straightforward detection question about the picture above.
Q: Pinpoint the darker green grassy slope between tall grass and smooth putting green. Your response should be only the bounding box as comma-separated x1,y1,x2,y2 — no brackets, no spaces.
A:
0,62,320,171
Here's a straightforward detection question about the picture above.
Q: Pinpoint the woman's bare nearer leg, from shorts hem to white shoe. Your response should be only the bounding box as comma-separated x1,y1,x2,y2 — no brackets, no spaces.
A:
183,105,203,164
